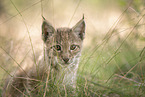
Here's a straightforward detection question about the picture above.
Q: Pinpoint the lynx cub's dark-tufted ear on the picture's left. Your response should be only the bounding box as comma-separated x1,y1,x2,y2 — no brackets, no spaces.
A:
42,20,55,42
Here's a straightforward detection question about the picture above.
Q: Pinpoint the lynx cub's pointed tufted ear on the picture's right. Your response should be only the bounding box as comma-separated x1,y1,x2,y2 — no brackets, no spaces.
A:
72,16,85,40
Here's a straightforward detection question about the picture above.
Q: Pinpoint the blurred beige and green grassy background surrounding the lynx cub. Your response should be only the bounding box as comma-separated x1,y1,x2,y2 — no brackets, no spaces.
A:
0,0,145,97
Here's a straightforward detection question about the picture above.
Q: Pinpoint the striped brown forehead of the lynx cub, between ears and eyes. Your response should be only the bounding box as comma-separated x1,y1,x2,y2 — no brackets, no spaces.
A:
55,28,81,44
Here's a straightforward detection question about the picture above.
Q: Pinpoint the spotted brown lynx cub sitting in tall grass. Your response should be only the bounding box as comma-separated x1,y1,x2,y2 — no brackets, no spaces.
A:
3,17,85,97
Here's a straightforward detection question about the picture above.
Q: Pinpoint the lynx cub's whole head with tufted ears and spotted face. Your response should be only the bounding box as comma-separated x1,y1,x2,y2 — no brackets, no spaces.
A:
42,17,85,66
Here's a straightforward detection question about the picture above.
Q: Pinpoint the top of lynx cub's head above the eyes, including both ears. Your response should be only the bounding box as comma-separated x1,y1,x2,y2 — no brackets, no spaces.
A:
42,18,85,47
